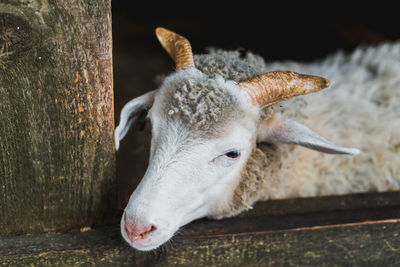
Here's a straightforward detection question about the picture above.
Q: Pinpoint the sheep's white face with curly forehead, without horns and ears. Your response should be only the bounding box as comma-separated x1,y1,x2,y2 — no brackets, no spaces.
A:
121,69,258,250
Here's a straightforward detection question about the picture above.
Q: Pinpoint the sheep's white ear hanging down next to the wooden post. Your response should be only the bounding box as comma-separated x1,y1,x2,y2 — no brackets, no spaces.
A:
115,90,156,151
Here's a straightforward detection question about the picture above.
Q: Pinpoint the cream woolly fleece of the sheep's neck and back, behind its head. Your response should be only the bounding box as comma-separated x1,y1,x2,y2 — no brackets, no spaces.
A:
195,42,400,216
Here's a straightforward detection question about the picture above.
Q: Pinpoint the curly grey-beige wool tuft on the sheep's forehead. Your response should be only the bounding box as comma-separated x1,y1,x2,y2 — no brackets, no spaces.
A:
163,70,241,133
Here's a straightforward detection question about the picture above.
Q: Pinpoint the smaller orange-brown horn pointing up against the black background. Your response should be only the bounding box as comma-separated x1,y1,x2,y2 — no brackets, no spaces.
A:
156,27,194,70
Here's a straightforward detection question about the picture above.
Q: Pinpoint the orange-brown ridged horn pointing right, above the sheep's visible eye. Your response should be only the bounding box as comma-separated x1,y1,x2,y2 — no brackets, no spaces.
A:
239,71,329,106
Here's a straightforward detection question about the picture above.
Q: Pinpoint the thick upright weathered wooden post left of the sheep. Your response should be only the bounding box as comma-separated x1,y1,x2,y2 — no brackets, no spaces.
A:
0,0,115,235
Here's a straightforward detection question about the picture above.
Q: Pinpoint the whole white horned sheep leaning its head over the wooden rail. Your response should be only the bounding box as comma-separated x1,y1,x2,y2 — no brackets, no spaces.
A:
115,28,400,250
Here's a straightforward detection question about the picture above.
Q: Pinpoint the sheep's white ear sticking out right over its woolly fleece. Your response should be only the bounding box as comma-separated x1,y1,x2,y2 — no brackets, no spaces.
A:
257,116,360,155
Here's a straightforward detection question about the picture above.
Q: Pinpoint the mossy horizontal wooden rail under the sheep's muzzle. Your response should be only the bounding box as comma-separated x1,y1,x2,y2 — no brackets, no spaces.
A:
0,207,400,266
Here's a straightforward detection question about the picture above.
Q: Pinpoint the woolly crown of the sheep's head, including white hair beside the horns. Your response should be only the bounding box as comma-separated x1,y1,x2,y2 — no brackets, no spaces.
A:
154,68,259,136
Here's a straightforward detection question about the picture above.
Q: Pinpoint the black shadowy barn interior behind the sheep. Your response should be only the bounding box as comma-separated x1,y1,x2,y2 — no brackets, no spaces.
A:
112,0,400,208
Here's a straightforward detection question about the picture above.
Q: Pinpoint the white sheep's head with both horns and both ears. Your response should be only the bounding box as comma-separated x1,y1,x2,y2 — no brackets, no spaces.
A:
115,28,358,250
